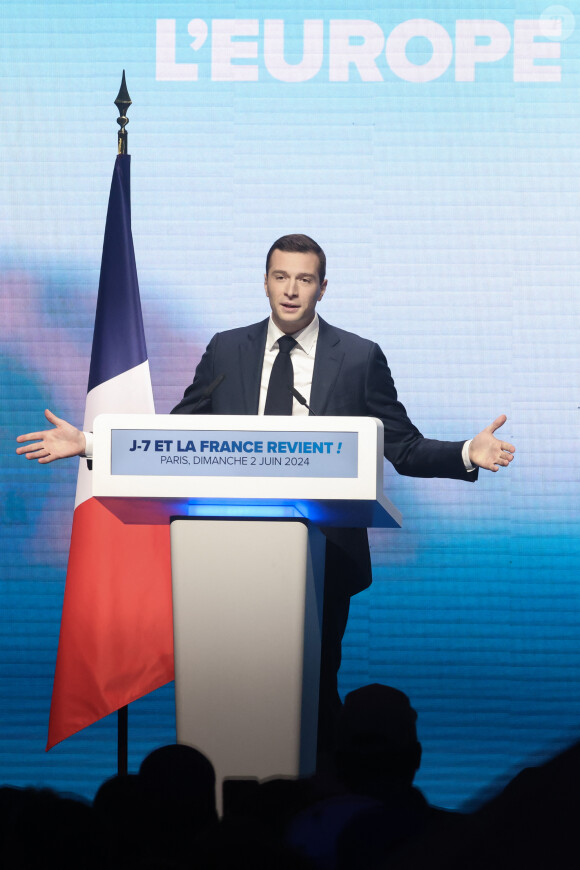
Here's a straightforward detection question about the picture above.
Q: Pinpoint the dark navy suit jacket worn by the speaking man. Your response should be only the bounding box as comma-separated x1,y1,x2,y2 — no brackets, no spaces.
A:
172,318,477,595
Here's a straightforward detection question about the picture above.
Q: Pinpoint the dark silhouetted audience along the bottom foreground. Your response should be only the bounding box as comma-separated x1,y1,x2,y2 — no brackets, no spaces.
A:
0,684,580,870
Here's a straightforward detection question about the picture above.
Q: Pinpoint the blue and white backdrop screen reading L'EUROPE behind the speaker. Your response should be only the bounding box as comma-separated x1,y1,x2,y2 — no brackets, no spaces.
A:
0,0,580,807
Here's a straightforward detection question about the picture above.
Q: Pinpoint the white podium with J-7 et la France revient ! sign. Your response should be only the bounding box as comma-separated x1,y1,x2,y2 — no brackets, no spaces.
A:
93,414,401,782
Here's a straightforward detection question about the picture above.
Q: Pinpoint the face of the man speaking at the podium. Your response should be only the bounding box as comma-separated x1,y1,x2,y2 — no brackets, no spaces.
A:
264,251,326,334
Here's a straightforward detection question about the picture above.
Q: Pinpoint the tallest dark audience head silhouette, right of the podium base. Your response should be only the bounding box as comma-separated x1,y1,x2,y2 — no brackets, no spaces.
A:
336,683,421,789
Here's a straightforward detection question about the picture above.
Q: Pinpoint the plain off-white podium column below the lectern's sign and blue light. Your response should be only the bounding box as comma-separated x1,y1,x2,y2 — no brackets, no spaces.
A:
171,519,324,784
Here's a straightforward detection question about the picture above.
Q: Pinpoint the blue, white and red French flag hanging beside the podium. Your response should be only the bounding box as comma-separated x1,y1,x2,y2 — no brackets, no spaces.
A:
46,155,173,749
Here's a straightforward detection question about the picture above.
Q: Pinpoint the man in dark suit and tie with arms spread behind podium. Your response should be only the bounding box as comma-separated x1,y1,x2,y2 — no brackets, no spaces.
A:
17,235,515,748
